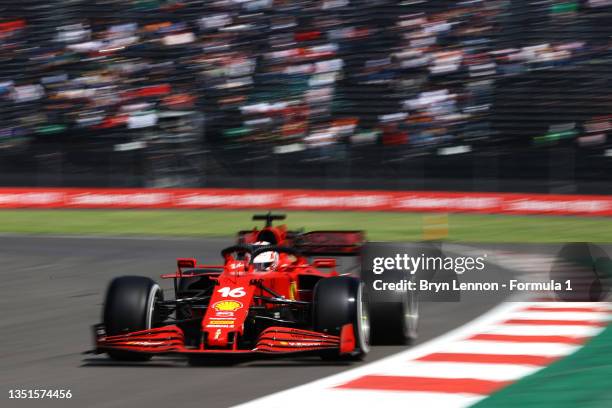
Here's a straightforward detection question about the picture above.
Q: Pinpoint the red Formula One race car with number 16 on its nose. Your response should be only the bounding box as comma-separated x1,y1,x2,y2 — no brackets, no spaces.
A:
94,242,370,361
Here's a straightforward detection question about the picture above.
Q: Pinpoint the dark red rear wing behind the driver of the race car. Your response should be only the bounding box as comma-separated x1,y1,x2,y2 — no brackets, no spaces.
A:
294,231,365,256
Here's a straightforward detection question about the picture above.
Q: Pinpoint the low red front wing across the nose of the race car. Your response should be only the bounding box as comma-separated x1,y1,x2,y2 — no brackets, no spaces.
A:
93,324,355,356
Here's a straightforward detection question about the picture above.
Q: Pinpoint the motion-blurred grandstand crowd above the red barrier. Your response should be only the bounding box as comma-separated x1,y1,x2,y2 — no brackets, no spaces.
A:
0,0,612,194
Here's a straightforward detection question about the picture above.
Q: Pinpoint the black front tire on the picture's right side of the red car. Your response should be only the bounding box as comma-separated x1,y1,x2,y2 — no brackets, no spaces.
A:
312,276,370,359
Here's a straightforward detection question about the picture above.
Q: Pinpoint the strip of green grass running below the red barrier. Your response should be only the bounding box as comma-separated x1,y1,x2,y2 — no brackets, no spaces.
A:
0,210,612,242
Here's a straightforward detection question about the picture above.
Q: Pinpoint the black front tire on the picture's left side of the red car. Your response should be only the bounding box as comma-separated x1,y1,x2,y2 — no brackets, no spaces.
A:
103,276,163,361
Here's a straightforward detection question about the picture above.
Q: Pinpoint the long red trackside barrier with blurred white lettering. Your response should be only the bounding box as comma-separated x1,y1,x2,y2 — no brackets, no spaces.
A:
0,188,612,216
